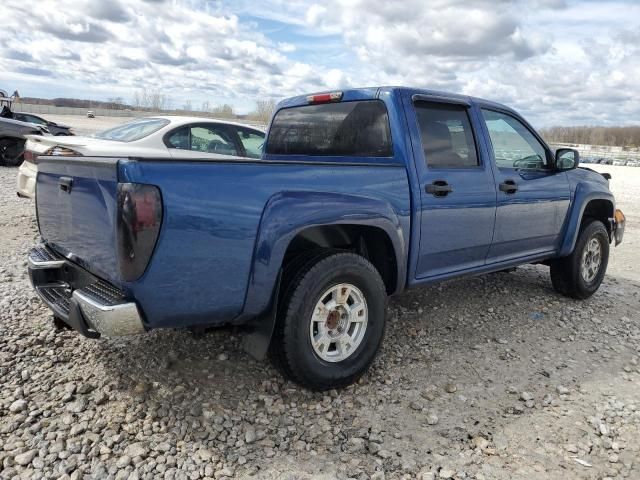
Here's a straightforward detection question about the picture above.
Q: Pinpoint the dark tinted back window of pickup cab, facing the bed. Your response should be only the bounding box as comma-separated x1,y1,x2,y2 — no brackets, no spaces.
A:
266,100,392,157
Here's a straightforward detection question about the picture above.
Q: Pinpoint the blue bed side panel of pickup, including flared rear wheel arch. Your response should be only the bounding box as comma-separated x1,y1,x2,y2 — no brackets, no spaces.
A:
120,160,410,327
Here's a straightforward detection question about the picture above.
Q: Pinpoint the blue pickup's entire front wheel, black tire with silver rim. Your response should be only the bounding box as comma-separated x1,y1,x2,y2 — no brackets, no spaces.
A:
551,220,609,299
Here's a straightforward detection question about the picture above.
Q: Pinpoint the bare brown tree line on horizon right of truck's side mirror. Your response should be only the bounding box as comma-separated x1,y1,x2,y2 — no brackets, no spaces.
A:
540,126,640,147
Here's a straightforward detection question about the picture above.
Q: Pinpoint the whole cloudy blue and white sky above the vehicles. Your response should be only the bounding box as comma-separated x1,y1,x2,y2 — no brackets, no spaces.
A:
0,0,640,127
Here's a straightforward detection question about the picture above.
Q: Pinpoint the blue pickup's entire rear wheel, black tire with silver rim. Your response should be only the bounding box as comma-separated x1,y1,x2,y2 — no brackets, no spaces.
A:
271,252,387,390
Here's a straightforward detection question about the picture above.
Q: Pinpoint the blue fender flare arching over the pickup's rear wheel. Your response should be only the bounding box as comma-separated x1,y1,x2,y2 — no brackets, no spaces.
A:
236,191,407,323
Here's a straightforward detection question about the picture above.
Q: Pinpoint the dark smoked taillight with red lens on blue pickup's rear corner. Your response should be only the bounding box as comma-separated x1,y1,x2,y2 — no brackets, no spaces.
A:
116,183,162,282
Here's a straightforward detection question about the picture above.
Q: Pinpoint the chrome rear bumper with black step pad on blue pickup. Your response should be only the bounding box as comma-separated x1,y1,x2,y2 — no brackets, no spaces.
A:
29,245,145,338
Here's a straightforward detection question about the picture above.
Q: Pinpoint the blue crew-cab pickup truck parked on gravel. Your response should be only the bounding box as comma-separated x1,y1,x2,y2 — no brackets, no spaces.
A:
29,87,625,390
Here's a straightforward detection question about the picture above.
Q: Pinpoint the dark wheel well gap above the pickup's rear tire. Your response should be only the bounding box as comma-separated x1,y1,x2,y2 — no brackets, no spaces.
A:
283,224,398,294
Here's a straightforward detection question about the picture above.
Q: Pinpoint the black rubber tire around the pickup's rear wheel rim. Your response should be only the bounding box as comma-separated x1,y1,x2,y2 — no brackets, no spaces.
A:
270,250,387,391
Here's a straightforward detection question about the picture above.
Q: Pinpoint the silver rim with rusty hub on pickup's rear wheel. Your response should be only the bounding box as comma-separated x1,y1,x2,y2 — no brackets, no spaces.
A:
309,283,369,362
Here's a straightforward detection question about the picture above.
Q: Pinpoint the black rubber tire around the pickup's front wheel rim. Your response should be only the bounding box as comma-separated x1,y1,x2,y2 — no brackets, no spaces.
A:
551,220,609,300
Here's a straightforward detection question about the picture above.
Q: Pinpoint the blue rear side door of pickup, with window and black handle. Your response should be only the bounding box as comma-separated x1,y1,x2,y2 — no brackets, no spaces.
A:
409,96,496,279
